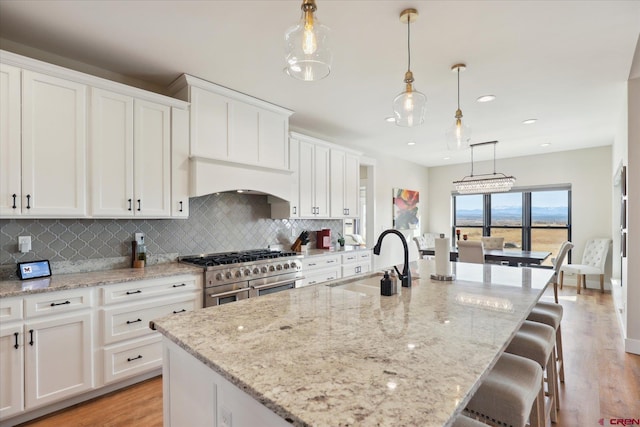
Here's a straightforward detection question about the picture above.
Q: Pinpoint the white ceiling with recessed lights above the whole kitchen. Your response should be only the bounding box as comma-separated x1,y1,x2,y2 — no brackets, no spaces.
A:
0,0,640,166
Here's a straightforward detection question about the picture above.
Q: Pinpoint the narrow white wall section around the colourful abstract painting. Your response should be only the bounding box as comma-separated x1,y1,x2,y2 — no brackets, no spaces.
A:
367,151,429,271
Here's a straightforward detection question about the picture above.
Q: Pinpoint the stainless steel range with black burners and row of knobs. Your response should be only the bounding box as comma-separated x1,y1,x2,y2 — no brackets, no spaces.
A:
178,249,303,307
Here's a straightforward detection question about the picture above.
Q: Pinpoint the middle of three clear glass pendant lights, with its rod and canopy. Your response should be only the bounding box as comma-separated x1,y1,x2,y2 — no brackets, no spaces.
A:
393,9,427,127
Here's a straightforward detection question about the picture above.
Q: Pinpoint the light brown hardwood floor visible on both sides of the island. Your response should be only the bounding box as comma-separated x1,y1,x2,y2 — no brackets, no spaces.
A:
17,286,640,427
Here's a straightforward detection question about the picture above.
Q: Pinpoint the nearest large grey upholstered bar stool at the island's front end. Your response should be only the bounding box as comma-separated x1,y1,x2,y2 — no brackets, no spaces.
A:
466,353,545,427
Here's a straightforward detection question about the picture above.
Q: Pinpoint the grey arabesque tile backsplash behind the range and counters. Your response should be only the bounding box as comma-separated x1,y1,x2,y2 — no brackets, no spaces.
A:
0,193,342,278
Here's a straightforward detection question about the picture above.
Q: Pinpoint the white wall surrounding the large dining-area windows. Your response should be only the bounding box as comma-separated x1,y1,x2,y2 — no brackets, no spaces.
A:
427,146,612,288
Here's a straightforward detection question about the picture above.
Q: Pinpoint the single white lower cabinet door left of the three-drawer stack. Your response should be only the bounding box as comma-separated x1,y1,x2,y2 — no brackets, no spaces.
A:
24,311,93,409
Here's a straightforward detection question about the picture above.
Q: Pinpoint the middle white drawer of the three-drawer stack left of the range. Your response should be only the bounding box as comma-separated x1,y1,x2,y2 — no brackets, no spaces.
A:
102,293,202,344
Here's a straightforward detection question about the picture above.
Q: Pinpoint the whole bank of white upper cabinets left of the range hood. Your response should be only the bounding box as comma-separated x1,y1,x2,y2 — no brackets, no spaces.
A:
0,50,189,218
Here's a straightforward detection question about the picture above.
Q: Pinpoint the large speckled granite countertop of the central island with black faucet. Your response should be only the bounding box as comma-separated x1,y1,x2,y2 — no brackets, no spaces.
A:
154,260,553,426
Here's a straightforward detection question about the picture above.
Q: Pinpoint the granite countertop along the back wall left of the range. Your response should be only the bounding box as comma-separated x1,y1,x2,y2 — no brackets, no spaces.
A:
0,262,202,298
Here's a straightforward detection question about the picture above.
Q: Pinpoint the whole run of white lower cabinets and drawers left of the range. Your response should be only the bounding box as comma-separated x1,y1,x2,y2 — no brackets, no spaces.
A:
0,274,202,426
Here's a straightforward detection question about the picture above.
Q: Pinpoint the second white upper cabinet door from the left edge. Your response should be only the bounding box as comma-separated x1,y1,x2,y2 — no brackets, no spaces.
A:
22,70,87,218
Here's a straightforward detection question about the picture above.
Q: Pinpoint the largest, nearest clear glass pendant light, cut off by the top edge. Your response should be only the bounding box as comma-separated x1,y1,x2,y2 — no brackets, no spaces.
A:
284,0,333,81
